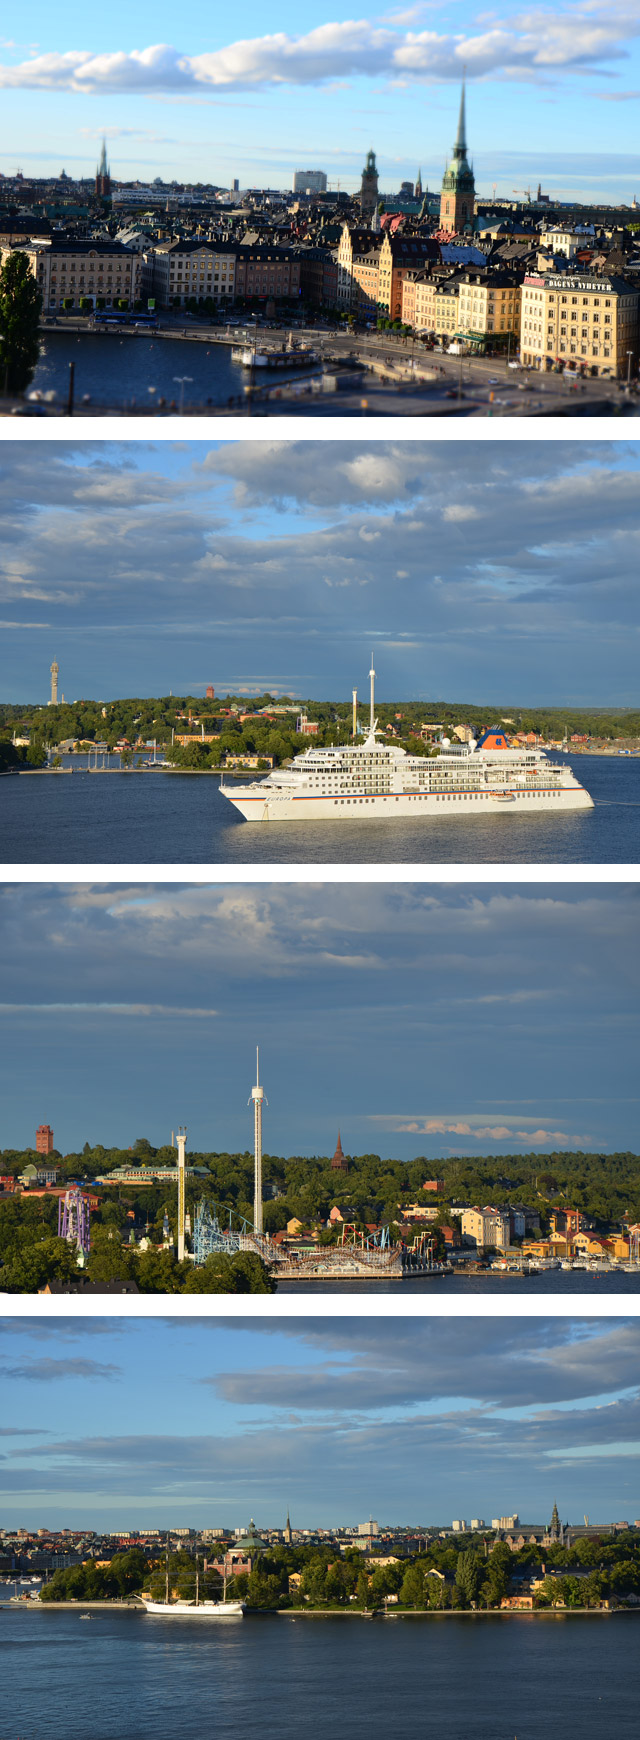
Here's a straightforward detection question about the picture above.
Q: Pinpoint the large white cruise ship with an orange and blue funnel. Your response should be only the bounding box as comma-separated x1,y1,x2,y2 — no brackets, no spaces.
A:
221,670,593,821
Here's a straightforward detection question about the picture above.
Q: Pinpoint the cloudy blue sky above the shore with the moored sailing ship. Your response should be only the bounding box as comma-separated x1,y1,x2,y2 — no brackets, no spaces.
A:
0,1314,640,1531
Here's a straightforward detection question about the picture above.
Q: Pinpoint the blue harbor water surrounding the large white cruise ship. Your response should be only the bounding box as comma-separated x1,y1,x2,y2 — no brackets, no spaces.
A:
0,755,640,865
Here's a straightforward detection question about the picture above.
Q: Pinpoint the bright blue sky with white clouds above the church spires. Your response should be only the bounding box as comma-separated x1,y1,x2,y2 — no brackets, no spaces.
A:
0,0,640,204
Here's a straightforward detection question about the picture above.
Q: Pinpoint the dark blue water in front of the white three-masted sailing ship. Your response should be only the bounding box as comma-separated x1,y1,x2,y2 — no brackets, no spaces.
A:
0,1610,640,1740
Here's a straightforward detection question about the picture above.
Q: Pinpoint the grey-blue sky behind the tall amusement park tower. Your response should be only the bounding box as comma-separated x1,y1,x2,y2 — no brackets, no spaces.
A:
0,879,638,1159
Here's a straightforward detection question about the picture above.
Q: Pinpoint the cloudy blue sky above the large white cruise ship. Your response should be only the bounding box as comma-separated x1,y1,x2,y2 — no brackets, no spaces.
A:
0,438,640,706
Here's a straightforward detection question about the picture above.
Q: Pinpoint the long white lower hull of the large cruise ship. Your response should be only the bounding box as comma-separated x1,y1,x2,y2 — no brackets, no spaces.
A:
224,780,593,821
